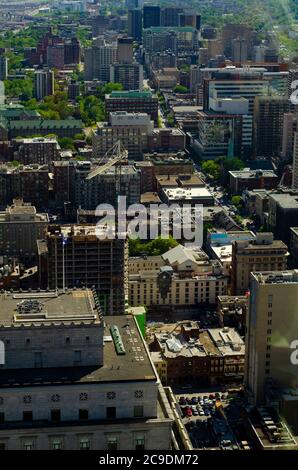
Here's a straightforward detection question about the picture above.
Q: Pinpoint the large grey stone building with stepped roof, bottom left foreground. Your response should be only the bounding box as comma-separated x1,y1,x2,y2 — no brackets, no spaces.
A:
0,289,174,452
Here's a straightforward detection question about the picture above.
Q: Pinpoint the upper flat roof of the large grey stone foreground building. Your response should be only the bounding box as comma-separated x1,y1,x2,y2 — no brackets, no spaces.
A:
0,289,100,328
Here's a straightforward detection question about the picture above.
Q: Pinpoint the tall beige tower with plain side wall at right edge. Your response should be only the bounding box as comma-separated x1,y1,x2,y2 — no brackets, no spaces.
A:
245,270,298,404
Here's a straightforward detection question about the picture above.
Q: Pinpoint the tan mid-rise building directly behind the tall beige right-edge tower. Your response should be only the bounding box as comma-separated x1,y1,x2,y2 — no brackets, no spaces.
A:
232,233,288,295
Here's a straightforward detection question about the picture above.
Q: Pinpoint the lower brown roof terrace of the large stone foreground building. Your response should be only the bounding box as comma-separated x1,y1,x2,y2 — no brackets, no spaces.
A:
0,315,157,387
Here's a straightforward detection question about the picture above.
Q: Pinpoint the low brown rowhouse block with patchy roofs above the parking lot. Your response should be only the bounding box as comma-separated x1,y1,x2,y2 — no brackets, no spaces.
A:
149,321,245,386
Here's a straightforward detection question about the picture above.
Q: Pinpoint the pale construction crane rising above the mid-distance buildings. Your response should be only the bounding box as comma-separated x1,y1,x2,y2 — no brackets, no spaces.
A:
86,140,128,194
